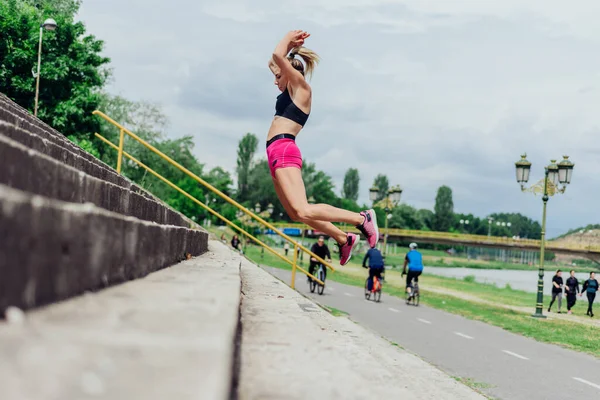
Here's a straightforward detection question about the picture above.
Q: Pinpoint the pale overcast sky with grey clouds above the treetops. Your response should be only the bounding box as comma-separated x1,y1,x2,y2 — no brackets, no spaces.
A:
79,0,600,236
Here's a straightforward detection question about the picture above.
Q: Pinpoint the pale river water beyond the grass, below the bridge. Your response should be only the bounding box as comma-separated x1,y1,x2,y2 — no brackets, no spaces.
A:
424,267,600,304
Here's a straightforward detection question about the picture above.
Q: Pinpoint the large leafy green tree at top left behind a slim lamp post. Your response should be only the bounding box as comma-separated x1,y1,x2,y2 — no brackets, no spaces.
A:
0,0,110,140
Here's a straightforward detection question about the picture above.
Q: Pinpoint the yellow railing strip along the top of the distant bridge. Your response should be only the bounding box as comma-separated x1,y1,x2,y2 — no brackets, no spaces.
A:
274,222,600,252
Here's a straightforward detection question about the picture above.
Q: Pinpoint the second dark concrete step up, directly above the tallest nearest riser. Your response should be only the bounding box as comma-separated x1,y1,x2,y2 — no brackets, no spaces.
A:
0,133,190,227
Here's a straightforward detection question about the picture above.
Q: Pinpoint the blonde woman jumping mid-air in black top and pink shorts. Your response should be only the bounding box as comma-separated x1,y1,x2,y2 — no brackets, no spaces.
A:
267,30,379,265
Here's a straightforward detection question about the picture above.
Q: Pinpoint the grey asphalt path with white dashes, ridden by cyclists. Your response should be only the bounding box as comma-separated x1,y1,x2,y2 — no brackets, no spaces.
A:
266,267,600,400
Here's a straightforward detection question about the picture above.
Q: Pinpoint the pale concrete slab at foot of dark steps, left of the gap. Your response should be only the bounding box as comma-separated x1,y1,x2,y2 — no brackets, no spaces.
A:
0,241,240,400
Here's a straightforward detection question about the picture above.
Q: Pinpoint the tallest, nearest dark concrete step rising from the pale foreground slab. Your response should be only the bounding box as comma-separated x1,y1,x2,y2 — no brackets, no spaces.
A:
0,184,208,312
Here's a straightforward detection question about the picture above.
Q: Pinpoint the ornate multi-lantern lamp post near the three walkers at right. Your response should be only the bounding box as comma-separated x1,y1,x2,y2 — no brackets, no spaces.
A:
515,154,575,318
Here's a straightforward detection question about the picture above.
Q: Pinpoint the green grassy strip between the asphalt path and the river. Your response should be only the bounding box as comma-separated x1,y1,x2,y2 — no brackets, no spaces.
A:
246,246,600,358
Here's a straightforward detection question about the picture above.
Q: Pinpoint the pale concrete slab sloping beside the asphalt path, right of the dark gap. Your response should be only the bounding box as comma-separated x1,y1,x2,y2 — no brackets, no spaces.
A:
237,260,485,400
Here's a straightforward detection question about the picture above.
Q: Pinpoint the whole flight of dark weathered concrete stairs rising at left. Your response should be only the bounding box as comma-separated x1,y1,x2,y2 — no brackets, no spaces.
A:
0,95,208,314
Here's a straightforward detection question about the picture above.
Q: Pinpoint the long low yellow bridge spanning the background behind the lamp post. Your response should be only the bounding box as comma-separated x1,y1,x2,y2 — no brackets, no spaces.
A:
274,223,600,262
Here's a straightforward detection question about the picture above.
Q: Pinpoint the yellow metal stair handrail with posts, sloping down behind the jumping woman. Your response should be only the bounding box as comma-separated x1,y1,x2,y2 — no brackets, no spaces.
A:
93,110,335,288
